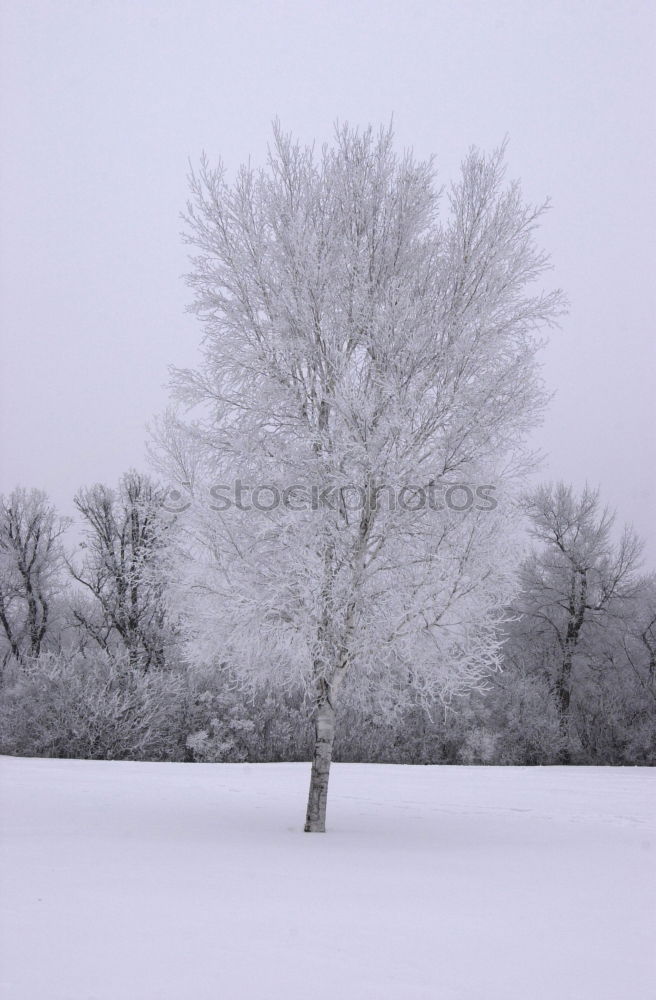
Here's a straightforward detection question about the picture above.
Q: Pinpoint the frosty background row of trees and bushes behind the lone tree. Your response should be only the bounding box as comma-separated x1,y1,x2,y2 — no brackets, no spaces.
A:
0,472,656,765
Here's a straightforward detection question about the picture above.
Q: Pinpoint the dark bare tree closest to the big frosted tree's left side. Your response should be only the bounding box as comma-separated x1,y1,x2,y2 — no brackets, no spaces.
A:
70,471,172,670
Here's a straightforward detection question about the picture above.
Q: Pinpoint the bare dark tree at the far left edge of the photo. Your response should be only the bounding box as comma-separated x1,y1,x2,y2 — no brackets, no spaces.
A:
0,489,70,661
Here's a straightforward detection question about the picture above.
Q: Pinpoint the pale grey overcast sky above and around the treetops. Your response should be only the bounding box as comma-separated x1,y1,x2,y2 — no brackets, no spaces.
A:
0,0,656,565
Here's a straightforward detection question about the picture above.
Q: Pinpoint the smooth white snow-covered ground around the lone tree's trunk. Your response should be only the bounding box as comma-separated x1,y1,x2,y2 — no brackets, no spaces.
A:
0,758,656,1000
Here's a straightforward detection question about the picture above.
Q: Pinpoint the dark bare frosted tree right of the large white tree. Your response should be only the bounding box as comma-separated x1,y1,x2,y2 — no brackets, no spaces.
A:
517,482,642,763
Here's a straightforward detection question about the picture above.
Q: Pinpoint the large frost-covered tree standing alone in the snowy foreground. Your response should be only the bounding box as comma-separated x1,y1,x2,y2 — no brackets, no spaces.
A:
160,126,562,831
